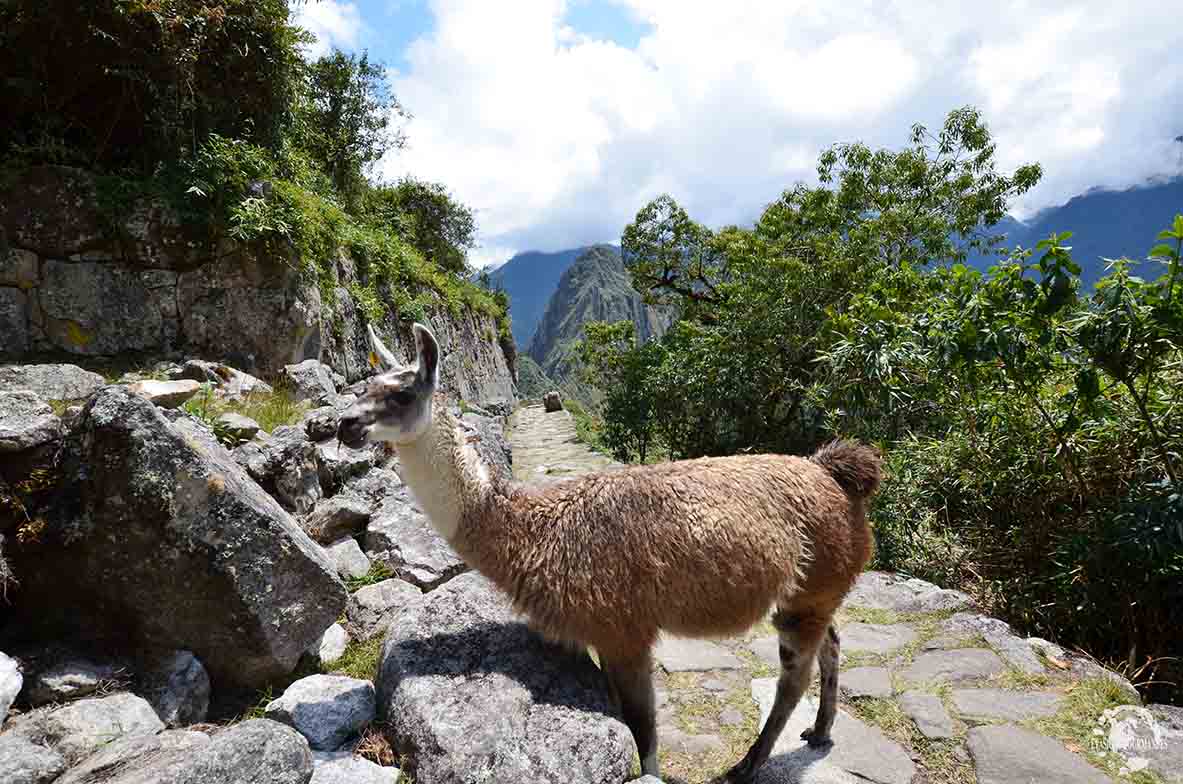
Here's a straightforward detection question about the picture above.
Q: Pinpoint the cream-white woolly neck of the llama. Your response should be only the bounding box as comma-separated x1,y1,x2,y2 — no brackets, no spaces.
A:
397,401,494,543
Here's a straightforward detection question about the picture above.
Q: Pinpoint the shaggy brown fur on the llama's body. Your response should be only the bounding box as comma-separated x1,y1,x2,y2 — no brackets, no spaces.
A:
453,449,878,659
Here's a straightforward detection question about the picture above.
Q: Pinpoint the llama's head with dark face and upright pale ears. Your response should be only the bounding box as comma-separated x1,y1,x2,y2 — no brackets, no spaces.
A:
337,324,440,447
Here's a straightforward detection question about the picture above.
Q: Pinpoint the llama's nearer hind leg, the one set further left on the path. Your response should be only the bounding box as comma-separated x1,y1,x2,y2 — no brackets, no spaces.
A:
726,610,829,784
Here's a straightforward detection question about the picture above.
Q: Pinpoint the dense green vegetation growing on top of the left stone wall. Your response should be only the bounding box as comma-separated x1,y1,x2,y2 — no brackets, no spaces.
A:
0,0,509,338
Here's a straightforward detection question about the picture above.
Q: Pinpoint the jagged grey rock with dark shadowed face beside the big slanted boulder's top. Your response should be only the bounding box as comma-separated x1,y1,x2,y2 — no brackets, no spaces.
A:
234,425,322,514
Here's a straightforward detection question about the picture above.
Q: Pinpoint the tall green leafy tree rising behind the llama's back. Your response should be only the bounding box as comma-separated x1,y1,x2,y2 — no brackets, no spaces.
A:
621,109,1040,456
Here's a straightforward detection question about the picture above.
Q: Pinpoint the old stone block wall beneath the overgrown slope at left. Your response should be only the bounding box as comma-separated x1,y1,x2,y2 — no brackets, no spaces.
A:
0,167,513,401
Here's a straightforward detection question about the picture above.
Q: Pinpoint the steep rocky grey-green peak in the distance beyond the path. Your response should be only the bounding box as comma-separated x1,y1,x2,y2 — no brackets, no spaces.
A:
526,245,670,394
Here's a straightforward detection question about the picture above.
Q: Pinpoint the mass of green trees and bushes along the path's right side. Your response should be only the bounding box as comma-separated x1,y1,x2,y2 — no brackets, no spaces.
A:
581,109,1183,699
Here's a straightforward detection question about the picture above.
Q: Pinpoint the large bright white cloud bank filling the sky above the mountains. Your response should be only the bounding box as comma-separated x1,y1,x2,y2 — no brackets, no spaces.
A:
383,0,1183,261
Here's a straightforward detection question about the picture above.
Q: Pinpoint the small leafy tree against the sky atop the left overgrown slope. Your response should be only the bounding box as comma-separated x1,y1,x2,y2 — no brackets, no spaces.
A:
297,51,407,212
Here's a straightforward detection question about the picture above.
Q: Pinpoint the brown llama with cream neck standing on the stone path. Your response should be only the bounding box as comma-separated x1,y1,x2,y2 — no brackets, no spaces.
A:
337,324,880,783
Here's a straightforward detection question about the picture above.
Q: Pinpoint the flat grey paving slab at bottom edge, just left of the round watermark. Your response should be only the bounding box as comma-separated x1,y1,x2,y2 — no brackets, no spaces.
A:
968,725,1110,784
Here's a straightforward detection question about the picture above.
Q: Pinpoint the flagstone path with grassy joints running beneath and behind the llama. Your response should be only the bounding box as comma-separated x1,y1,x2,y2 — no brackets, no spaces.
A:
510,406,1183,784
